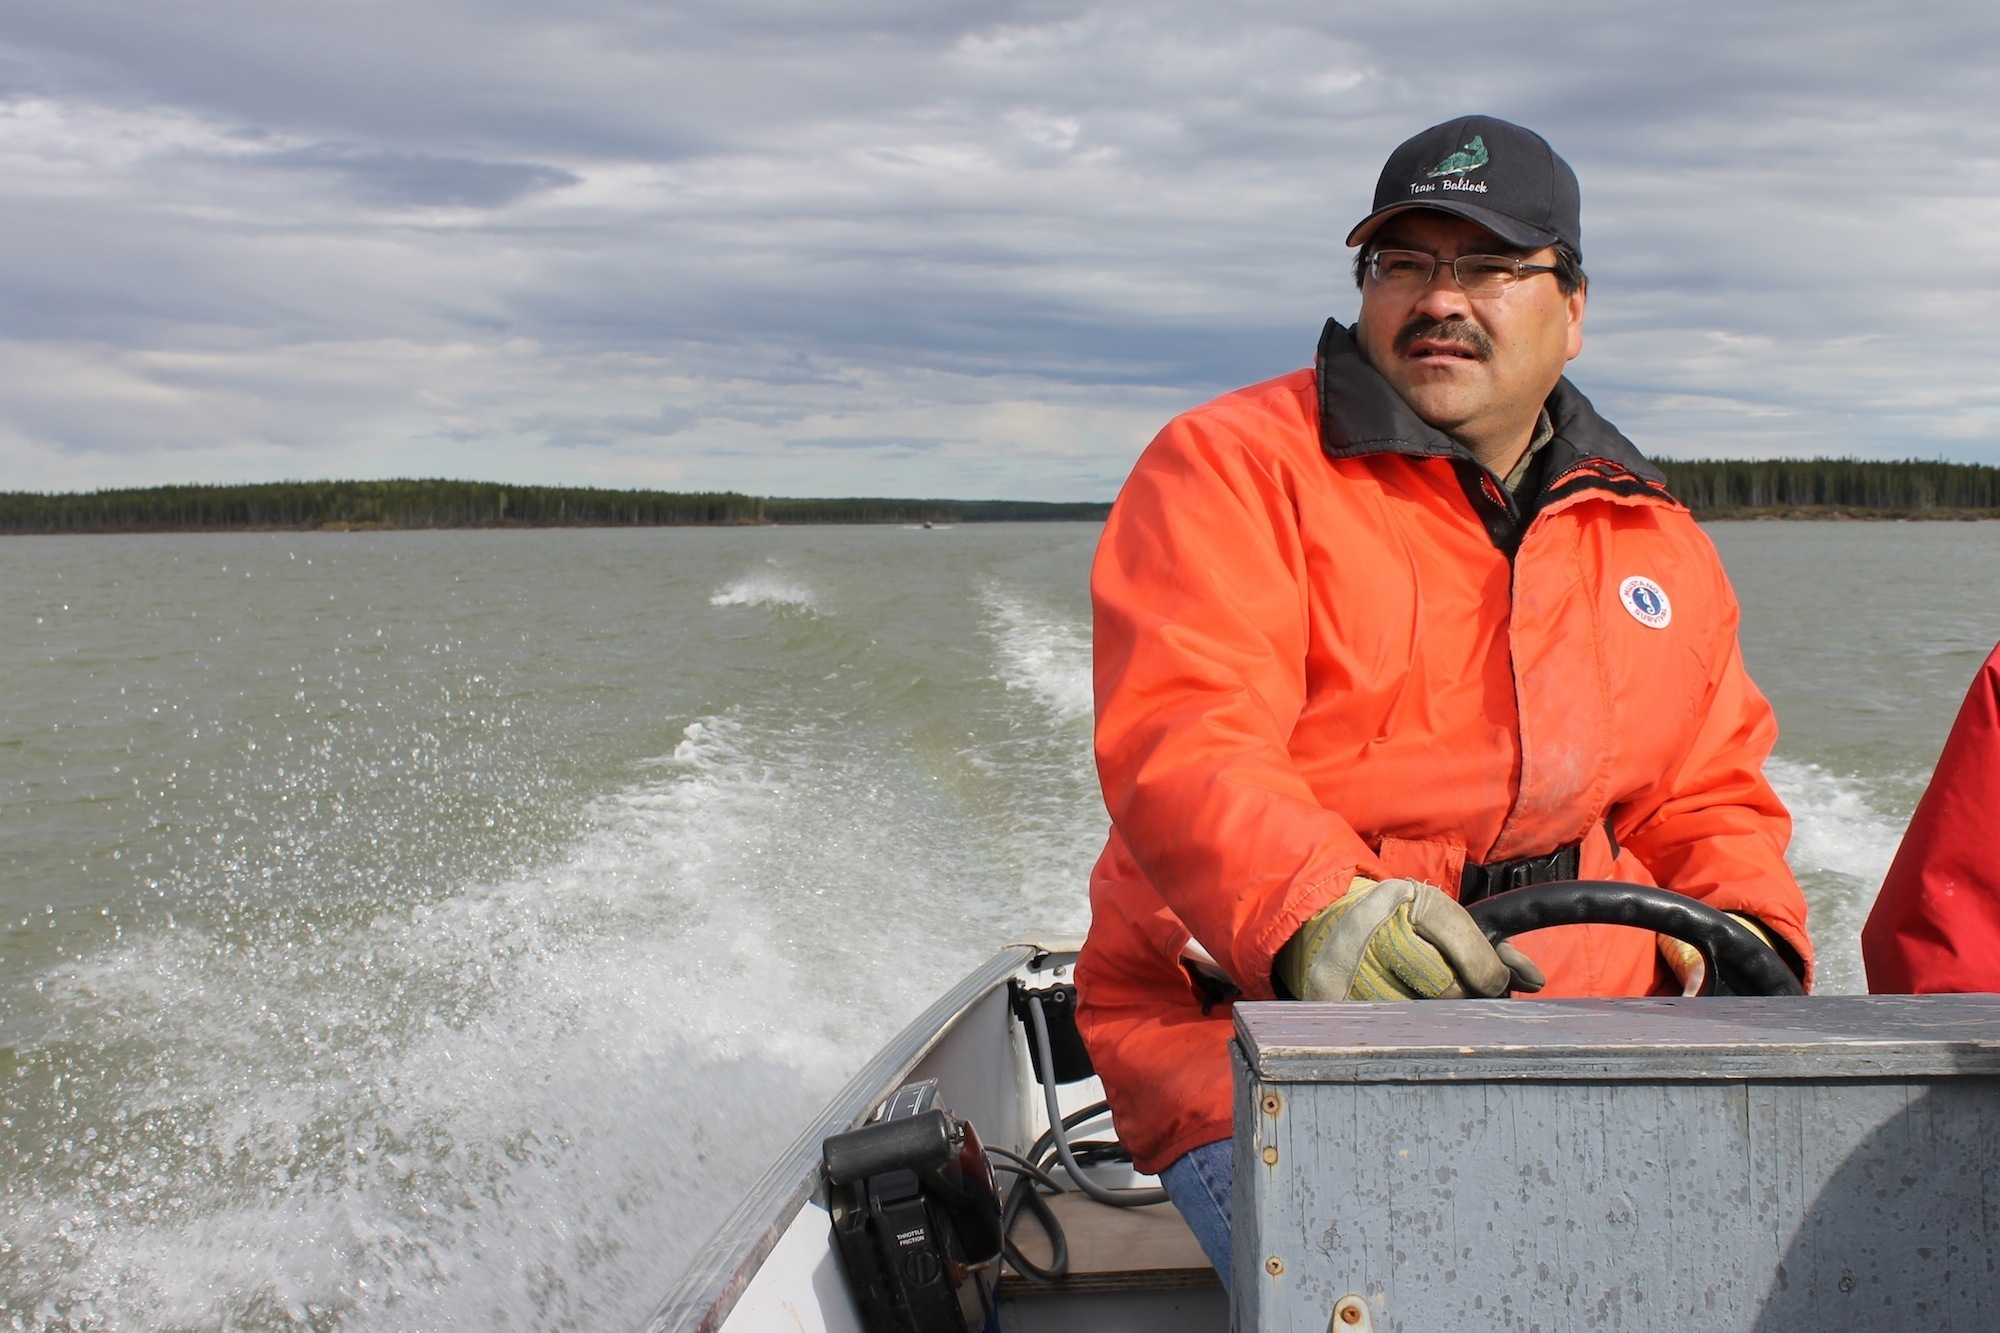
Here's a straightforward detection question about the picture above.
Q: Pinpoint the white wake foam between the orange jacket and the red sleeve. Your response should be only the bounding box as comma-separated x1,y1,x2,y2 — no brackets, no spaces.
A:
1764,757,1904,995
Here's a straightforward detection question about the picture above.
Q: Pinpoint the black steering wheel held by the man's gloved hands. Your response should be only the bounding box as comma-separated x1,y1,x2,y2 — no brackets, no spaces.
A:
1466,879,1806,995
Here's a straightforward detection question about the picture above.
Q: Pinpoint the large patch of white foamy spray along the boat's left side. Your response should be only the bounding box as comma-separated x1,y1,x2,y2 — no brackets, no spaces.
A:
0,717,930,1329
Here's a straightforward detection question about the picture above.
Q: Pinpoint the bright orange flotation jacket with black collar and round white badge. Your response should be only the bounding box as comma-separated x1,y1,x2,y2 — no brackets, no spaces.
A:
1078,322,1812,1171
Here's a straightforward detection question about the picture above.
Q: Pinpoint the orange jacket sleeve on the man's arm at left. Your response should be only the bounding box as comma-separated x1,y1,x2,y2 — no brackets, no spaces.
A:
1090,392,1382,984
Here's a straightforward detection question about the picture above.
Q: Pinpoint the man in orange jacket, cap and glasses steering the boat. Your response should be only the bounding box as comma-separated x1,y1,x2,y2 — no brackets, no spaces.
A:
1078,116,1812,1279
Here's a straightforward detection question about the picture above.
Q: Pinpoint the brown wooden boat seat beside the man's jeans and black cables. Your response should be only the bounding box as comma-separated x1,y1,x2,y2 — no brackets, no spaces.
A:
1000,1193,1220,1297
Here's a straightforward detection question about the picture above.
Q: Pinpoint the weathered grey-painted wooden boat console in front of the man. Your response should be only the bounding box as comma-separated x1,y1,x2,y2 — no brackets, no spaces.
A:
1232,995,2000,1333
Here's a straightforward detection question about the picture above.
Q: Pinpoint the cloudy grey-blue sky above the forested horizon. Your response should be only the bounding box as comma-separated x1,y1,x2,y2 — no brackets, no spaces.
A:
0,0,2000,500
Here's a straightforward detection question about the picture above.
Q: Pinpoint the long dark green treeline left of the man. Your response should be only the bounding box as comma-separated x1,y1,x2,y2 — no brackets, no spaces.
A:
0,480,1110,532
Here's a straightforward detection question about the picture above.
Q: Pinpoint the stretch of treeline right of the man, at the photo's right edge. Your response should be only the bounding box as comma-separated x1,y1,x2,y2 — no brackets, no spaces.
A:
1654,458,2000,518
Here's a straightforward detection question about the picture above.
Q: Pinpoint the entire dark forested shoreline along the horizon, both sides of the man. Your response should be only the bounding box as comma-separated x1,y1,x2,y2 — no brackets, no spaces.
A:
0,458,2000,534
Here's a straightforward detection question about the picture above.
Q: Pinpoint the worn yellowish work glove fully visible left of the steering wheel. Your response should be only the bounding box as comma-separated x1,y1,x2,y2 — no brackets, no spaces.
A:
1272,875,1544,1001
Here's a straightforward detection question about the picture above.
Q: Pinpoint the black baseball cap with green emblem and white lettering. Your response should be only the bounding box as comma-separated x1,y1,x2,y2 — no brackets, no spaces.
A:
1348,116,1584,254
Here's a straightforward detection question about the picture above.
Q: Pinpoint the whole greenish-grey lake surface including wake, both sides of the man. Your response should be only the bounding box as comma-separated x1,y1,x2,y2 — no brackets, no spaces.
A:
0,524,2000,1329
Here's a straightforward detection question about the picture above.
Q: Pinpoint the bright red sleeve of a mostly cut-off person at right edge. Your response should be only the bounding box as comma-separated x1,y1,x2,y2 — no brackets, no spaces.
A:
1862,648,2000,995
